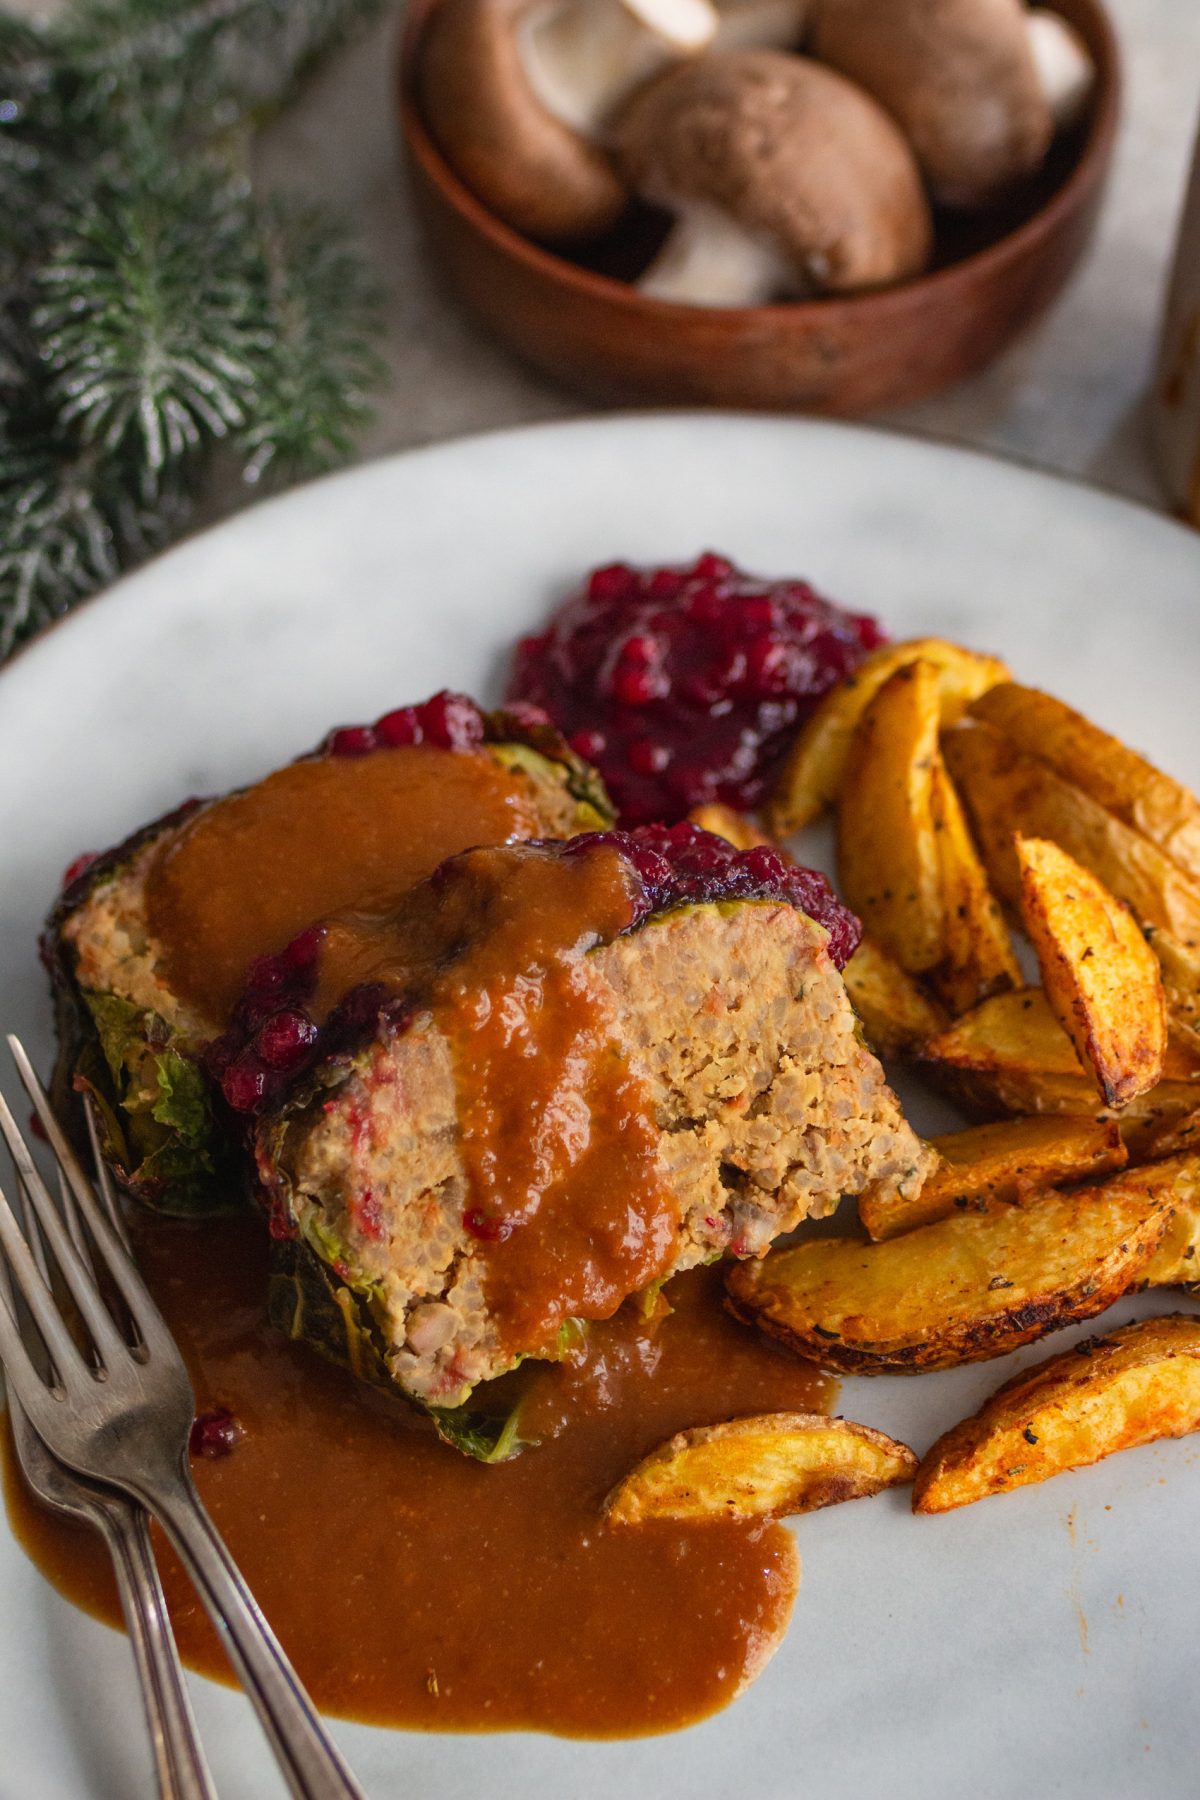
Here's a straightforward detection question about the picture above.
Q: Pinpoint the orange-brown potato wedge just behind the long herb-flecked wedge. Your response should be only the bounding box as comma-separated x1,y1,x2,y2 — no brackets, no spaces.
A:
858,1116,1128,1244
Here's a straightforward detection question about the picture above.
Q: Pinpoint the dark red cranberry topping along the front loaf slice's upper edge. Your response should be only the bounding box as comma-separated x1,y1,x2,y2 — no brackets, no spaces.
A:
205,824,862,1112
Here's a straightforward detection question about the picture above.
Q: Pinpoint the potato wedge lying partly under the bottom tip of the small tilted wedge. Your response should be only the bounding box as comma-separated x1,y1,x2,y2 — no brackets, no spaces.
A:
918,988,1200,1139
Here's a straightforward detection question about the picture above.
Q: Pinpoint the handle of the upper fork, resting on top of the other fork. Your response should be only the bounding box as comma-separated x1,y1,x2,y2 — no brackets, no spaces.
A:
140,1465,365,1800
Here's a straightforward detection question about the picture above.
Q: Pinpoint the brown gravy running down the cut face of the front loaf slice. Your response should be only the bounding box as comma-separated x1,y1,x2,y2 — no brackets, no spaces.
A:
313,844,678,1355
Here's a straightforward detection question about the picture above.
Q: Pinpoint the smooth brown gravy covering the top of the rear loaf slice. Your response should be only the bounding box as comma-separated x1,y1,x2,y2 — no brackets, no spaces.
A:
148,745,550,1022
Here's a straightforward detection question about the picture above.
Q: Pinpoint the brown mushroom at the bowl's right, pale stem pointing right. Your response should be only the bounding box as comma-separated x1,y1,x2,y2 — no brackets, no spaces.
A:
811,0,1094,207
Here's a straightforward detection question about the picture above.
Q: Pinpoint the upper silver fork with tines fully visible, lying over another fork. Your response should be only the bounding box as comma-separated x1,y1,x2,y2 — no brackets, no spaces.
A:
0,1037,363,1800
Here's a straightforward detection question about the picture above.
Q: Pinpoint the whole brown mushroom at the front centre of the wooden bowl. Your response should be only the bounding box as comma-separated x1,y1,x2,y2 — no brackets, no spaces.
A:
615,50,932,306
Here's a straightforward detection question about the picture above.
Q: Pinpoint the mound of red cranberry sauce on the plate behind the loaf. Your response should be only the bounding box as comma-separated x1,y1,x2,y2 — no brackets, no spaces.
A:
509,554,883,824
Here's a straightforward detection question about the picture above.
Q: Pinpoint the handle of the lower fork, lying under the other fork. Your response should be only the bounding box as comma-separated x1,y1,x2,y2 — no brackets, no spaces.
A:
94,1494,216,1800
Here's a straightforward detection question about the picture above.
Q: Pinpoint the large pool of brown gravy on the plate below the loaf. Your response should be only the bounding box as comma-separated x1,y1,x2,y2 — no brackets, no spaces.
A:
2,1219,833,1737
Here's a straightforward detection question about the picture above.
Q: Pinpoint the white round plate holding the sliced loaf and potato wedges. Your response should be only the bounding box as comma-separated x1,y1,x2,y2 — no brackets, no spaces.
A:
0,414,1200,1800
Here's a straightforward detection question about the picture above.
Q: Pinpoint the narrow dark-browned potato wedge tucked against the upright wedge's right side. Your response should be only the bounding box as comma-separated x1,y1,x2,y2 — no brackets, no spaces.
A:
930,754,1022,1015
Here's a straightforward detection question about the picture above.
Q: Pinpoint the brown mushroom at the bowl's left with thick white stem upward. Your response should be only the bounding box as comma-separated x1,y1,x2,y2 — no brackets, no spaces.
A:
419,0,716,239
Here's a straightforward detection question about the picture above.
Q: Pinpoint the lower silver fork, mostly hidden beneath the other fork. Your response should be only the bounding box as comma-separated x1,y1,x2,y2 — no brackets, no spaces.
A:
0,1137,216,1800
